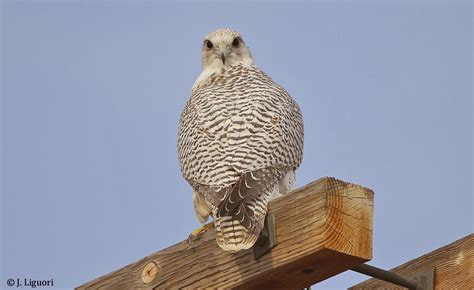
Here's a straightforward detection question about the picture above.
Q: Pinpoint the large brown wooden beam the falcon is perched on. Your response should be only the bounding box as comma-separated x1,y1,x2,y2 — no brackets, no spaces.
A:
79,178,373,289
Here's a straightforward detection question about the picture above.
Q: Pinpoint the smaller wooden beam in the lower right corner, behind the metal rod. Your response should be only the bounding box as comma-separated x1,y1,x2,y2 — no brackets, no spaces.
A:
349,234,474,289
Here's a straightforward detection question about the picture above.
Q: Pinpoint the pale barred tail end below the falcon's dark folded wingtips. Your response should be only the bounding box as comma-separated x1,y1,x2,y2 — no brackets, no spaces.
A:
214,216,264,252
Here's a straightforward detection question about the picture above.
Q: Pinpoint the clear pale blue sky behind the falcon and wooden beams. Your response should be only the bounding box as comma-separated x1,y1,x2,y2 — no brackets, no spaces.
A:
0,0,473,289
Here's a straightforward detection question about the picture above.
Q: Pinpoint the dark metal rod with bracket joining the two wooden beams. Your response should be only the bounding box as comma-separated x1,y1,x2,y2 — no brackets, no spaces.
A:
352,264,435,290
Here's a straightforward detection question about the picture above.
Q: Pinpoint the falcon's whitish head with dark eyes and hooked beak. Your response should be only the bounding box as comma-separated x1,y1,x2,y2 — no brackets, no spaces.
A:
202,29,253,70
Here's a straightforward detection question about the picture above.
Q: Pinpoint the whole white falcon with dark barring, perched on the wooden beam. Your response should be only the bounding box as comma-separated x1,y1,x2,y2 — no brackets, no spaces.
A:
178,29,303,252
